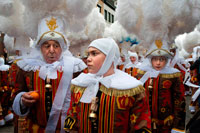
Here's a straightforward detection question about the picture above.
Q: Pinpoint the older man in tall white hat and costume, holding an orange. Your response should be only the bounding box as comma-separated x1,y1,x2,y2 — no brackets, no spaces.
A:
13,16,86,132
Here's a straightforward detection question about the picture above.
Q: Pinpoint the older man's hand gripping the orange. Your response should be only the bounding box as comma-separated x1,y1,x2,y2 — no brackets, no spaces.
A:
21,91,37,107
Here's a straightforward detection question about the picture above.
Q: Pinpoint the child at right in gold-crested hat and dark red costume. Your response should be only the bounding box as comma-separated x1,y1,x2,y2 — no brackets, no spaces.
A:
136,40,185,133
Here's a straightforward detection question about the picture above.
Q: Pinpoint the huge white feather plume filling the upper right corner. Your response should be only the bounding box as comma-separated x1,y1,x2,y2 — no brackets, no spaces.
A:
116,0,200,48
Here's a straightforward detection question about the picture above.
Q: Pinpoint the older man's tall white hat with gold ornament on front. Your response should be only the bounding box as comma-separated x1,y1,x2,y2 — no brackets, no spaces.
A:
35,16,69,50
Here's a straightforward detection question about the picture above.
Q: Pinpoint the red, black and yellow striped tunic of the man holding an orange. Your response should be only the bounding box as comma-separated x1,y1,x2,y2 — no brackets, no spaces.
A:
15,69,63,133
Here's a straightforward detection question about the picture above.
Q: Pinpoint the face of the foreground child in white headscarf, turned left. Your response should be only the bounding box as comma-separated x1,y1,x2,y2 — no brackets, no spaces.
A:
87,47,106,74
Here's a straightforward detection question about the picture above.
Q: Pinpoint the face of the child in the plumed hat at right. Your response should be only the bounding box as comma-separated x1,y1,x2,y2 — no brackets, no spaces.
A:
151,56,167,71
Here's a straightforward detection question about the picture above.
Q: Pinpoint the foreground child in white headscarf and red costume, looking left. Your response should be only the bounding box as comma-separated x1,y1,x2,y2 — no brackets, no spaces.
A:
65,38,151,133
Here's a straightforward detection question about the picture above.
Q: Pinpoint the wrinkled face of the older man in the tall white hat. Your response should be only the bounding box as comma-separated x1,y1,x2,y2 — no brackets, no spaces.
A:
41,40,62,64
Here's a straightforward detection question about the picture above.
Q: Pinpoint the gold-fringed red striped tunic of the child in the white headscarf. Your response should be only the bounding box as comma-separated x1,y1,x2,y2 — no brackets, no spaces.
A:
68,85,151,133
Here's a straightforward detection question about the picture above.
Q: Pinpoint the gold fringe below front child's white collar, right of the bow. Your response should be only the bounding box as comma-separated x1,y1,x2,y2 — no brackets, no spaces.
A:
100,85,145,96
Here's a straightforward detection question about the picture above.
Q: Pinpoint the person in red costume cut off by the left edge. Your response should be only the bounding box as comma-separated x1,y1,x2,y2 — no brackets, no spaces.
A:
0,57,13,126
